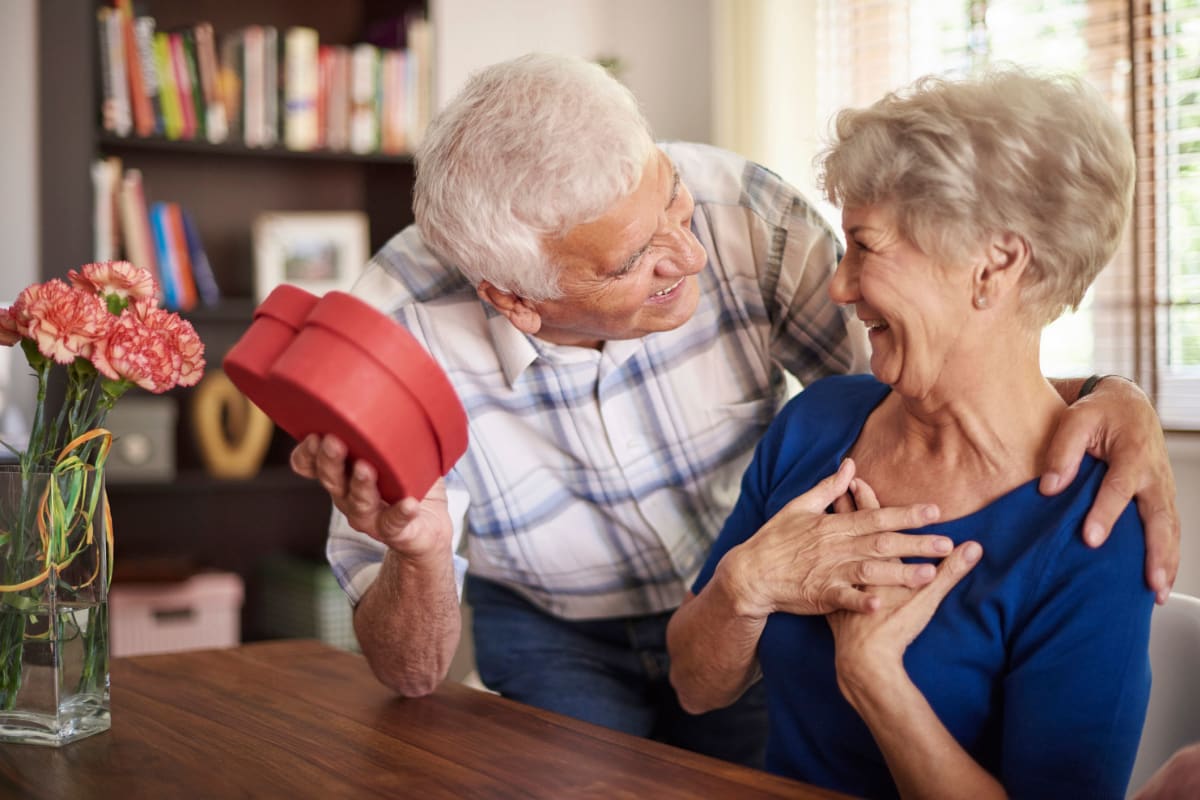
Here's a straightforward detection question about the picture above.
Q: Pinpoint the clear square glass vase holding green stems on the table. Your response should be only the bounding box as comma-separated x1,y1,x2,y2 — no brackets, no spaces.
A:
0,462,112,746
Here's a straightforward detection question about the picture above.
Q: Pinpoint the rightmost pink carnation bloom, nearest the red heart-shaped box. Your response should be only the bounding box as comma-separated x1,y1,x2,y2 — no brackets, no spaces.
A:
92,299,204,393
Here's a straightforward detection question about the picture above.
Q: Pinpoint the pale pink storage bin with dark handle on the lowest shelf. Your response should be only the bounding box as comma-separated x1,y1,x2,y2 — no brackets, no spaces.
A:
108,572,245,656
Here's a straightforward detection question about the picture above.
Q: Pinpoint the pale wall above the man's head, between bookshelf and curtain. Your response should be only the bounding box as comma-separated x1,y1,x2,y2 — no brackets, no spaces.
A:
430,0,712,142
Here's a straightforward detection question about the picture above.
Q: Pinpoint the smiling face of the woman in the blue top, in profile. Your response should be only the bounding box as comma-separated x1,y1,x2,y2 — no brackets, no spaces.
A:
829,205,972,397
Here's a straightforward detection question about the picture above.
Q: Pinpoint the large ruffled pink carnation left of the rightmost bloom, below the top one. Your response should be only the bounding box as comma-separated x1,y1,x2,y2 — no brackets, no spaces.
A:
18,278,113,363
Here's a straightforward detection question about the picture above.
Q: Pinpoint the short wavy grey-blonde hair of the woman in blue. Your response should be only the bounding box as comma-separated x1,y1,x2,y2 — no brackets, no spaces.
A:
818,67,1135,325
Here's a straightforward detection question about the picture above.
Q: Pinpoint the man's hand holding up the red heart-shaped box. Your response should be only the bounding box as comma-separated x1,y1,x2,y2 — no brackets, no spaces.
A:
290,434,454,557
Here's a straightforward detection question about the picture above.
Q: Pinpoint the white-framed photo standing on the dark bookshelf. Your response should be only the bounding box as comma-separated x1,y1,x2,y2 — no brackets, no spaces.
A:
254,211,370,302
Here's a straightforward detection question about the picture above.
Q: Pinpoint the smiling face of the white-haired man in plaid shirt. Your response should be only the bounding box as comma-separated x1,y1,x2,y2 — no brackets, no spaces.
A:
533,150,708,347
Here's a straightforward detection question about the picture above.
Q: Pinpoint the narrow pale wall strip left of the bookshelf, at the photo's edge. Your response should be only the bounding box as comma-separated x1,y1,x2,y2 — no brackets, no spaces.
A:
0,0,38,439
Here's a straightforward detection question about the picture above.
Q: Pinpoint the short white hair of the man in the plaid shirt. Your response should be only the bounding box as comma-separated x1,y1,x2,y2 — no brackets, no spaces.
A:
413,54,654,300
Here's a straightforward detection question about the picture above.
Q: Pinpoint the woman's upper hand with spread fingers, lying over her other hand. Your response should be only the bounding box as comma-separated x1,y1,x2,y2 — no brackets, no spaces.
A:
725,458,953,618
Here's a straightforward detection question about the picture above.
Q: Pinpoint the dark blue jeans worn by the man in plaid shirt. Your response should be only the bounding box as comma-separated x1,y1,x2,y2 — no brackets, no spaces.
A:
466,576,767,769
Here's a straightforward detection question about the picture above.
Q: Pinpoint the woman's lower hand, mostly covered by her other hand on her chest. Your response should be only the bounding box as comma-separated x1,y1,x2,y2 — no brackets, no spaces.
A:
827,479,983,708
